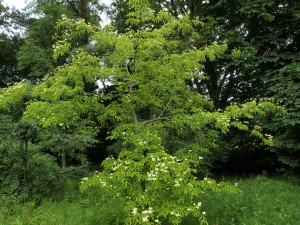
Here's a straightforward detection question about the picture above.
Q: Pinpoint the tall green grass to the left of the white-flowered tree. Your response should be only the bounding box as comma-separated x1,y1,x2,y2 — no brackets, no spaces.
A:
0,181,125,225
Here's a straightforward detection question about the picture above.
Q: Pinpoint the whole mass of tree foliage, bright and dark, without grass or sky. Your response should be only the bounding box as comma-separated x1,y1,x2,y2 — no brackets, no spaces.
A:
0,0,300,224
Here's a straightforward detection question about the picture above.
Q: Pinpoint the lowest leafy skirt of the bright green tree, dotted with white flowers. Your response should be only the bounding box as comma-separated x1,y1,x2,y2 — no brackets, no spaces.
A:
81,150,224,224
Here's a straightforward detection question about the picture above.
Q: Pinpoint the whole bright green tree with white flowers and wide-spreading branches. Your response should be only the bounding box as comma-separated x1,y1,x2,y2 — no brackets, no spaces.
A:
24,1,277,224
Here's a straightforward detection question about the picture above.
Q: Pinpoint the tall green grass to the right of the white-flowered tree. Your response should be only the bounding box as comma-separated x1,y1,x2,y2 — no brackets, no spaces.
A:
202,176,300,225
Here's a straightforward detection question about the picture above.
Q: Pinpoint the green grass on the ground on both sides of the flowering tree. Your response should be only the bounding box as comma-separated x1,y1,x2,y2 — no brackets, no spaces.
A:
0,176,300,225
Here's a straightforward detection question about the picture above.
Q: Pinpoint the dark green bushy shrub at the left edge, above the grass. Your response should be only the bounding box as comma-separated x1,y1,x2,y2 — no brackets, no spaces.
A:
0,115,62,200
